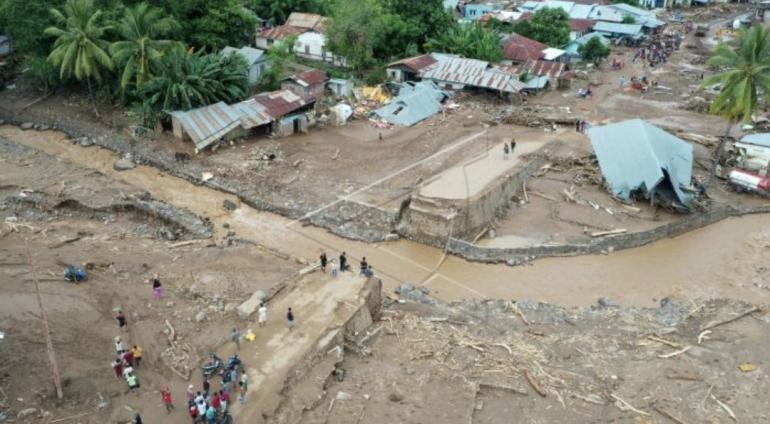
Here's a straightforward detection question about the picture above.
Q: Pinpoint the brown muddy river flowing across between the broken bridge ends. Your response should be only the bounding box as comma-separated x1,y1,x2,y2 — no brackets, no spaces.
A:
0,126,770,306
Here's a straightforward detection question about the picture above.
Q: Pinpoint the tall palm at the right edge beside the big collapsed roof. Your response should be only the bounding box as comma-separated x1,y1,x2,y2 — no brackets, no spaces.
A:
702,25,770,187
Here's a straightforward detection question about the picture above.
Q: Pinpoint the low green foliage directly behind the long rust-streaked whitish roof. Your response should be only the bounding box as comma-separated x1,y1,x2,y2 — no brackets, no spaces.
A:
425,22,503,62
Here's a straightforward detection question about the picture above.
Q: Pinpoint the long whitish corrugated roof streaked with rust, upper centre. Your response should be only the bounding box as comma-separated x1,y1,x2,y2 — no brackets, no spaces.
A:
420,56,525,93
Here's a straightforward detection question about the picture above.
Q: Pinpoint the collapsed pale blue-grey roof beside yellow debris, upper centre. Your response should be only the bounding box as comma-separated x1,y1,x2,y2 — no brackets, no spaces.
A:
372,81,447,126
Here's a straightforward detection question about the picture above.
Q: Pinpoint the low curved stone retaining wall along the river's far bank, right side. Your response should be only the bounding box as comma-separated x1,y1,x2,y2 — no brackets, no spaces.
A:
448,205,770,265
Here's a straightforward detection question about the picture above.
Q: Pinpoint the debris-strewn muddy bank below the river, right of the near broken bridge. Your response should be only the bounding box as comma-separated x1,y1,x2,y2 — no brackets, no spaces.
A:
280,296,770,424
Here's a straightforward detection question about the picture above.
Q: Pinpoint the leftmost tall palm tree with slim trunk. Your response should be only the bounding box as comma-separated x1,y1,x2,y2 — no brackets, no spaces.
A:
44,0,113,100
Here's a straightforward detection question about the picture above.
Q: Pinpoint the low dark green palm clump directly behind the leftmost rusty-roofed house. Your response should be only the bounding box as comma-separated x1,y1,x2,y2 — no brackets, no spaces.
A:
143,49,244,112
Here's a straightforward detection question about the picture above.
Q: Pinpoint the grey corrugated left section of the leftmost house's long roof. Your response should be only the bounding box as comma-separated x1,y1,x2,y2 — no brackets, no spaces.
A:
171,102,241,150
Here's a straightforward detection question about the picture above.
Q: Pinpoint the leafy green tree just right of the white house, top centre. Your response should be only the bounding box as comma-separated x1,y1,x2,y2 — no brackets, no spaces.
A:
326,0,388,72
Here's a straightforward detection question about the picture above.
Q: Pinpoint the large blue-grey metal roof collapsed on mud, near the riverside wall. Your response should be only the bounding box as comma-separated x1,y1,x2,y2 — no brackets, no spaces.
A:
588,119,693,205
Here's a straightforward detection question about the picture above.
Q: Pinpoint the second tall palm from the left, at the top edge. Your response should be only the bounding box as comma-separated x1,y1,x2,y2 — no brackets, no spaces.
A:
110,3,178,91
